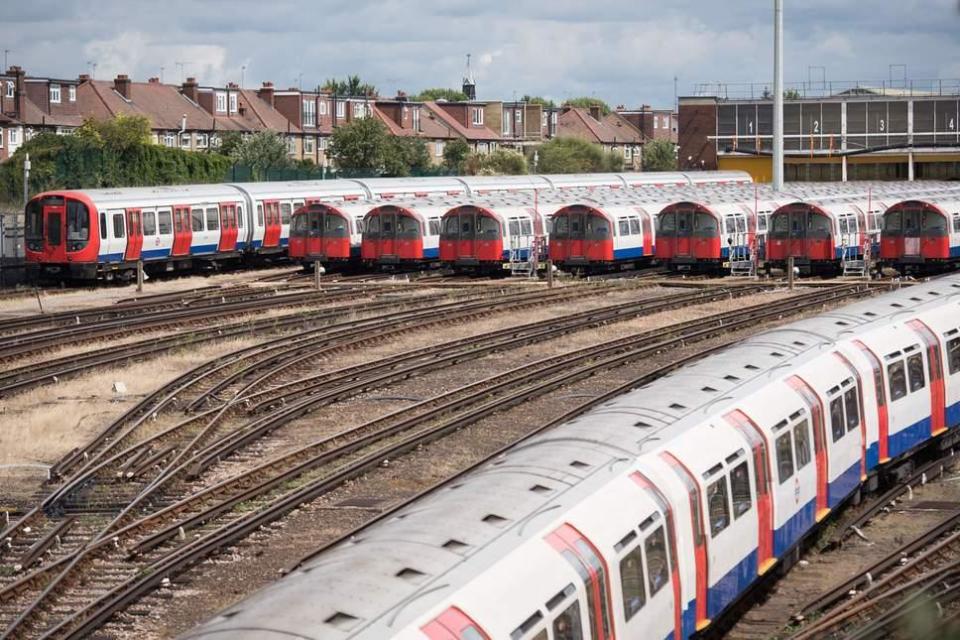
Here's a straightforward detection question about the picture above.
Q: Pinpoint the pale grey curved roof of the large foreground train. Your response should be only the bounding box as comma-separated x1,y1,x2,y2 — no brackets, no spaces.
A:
186,275,960,638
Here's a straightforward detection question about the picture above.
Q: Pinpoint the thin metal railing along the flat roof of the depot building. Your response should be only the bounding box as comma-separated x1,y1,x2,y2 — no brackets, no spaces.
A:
693,79,960,101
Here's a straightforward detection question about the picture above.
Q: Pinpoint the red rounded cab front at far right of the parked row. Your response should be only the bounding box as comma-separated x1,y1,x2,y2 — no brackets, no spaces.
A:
880,200,960,272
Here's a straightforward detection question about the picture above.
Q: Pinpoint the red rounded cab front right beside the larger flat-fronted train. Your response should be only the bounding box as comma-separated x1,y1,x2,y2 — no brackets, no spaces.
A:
290,203,360,265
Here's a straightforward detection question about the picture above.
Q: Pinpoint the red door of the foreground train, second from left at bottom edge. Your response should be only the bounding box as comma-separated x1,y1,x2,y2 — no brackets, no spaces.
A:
547,524,616,640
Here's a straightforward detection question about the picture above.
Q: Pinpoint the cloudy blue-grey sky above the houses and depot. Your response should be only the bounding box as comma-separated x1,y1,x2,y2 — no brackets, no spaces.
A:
0,0,960,107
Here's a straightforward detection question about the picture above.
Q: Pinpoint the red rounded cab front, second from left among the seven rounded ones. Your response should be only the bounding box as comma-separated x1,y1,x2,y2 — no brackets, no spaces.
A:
360,204,437,266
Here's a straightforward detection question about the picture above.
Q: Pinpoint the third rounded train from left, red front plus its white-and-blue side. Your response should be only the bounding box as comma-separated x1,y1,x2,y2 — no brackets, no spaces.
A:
440,200,549,273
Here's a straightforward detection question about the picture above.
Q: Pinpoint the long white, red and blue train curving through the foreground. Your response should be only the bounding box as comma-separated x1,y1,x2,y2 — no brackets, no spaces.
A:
183,276,960,640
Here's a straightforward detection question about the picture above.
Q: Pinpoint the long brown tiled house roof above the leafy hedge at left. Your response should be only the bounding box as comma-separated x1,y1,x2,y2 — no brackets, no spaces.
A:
77,80,216,131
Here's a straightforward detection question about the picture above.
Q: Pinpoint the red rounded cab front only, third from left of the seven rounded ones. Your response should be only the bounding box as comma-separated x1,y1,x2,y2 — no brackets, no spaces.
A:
440,205,506,272
